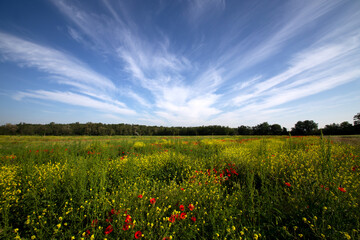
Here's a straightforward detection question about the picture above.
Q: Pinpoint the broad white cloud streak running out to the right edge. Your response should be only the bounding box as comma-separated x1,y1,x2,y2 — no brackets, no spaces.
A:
226,27,360,123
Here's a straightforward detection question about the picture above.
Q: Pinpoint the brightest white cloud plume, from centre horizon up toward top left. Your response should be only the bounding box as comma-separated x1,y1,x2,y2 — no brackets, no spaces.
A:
54,1,221,124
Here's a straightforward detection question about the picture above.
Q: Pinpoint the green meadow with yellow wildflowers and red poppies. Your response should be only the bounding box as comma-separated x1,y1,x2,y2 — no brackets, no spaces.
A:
0,136,360,239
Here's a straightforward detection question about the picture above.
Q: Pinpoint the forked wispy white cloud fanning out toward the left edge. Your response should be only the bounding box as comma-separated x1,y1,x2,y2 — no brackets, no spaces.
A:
0,32,135,115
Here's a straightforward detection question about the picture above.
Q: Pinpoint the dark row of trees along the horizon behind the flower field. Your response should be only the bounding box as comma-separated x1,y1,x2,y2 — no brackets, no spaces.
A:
0,113,360,136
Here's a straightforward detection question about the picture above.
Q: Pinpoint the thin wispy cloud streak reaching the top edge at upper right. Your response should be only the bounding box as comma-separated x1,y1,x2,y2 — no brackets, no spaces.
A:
217,0,340,79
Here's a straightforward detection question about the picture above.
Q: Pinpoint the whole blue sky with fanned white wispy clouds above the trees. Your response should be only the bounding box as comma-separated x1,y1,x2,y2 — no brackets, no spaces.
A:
0,0,360,128
